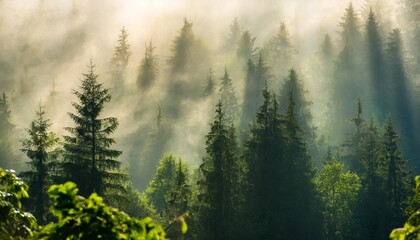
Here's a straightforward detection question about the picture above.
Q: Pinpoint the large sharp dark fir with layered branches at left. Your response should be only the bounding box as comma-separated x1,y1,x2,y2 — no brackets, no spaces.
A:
63,61,127,204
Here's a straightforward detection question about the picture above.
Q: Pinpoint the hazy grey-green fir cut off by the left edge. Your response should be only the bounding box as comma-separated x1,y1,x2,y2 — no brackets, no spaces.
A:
0,93,18,169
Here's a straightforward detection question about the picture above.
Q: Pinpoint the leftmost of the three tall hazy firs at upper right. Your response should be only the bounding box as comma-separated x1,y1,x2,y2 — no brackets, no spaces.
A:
329,3,364,144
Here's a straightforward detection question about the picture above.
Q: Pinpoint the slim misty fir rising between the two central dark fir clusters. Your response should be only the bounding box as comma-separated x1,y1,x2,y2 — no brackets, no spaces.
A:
219,68,238,124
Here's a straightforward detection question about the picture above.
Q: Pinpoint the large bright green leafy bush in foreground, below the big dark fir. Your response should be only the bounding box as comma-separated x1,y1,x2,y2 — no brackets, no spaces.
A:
33,182,165,240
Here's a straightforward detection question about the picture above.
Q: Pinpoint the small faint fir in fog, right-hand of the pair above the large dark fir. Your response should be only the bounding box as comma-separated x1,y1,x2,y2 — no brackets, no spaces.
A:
137,41,159,90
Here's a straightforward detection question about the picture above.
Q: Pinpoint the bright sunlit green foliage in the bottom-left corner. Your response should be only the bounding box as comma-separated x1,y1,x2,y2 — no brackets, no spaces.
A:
0,168,37,240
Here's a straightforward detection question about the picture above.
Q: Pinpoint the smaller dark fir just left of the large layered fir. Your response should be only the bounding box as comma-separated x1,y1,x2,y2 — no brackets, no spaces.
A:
20,105,59,224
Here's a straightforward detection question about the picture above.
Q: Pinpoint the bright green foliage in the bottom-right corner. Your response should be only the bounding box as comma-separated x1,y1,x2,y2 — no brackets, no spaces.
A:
390,176,420,240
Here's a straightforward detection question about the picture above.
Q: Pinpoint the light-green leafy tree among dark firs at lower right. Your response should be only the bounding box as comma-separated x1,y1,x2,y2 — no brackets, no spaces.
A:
315,157,362,240
